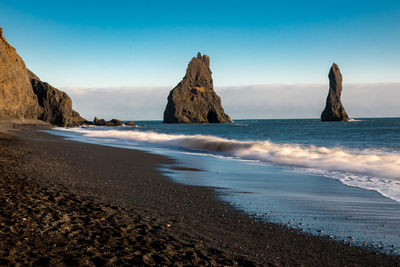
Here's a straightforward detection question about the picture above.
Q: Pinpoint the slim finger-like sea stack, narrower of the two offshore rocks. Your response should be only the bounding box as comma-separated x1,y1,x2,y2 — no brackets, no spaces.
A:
321,63,349,121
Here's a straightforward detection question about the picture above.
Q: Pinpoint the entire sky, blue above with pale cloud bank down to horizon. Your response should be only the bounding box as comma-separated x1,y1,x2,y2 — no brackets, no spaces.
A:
0,0,400,119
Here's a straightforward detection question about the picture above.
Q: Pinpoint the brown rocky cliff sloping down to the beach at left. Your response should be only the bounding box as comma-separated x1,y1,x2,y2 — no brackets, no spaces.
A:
0,28,85,126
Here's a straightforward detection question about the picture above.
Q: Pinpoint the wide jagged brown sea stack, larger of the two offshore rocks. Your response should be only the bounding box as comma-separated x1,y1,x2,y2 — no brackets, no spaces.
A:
164,52,232,123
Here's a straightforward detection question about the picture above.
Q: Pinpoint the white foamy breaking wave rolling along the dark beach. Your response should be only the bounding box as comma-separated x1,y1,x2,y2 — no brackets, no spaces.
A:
55,128,400,202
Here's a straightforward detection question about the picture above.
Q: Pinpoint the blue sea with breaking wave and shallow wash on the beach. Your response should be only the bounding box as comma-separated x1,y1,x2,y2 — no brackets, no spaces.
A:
48,118,400,255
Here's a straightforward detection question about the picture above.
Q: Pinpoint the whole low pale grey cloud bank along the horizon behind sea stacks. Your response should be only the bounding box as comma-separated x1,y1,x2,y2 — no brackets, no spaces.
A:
61,83,400,120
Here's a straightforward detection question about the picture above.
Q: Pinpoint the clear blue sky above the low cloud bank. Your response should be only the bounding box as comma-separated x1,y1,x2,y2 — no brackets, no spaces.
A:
0,0,400,88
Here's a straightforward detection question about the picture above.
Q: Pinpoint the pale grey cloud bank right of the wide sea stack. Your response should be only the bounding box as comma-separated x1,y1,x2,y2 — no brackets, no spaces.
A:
219,83,400,118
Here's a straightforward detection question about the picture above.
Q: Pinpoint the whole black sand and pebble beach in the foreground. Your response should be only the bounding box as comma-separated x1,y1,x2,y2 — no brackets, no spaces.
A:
0,121,400,266
